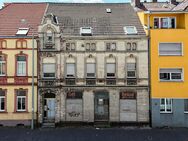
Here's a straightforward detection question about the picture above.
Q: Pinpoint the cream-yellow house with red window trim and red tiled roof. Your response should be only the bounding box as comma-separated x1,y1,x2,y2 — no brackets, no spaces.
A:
0,3,46,126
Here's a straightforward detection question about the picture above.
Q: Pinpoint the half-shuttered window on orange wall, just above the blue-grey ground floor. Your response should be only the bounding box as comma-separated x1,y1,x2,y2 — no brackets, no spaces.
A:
160,68,183,81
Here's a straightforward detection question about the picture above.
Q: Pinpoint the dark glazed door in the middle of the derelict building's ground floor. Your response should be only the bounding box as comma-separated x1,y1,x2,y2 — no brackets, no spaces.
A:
95,93,109,121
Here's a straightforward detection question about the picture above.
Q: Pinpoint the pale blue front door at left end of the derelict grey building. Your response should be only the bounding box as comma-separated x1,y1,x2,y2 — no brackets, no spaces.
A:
46,98,55,120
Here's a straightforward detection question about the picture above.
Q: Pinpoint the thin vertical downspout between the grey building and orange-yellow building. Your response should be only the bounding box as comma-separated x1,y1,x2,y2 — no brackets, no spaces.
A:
147,11,152,127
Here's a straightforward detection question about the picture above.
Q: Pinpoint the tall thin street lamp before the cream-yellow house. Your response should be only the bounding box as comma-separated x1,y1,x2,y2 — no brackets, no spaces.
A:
21,19,35,130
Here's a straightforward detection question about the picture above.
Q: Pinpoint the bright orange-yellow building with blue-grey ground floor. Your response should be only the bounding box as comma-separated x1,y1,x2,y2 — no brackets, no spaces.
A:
134,0,188,127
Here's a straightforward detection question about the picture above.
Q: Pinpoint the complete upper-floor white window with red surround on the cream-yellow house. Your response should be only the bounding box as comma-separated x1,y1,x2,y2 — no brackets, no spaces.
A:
16,56,27,76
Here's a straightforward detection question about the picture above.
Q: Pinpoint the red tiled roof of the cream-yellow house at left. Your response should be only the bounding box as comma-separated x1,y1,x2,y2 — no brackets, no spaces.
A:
0,3,47,36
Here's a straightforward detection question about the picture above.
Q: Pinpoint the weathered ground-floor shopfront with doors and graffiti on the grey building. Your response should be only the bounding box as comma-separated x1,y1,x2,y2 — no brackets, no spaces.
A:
38,87,149,124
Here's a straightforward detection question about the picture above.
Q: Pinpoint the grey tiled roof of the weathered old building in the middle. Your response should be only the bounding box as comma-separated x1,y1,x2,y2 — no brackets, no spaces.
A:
47,3,145,36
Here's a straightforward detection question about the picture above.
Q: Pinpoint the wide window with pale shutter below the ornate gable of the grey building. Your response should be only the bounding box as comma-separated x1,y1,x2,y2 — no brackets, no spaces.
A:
43,63,55,78
